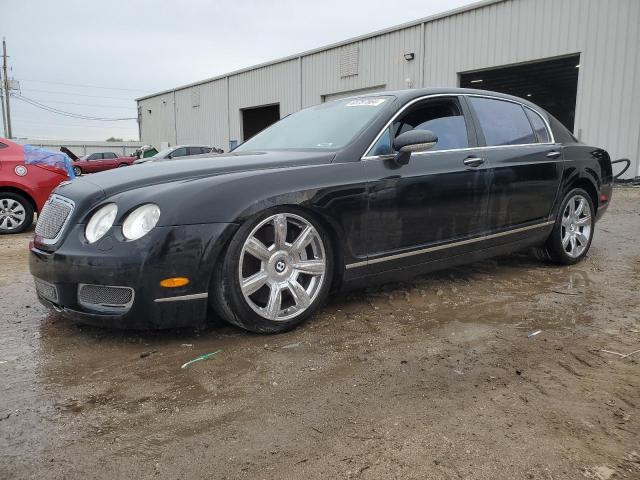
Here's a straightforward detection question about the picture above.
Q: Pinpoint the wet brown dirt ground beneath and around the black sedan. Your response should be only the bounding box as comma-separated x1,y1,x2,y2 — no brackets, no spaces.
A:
0,188,640,479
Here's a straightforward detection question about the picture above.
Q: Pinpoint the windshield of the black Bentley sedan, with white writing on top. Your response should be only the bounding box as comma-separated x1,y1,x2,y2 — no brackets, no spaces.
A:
234,96,393,152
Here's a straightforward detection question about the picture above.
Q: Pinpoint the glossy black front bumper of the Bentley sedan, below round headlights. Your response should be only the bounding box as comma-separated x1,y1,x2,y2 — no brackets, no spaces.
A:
29,223,236,329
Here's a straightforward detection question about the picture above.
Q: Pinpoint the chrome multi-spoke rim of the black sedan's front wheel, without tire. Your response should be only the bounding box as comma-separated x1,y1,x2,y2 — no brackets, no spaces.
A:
238,213,326,321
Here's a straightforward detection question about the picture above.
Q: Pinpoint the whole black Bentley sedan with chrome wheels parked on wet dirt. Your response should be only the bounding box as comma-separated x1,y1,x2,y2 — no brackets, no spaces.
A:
30,89,612,333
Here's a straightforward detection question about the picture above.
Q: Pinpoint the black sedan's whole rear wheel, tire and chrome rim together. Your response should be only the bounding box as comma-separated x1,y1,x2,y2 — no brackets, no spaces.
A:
544,188,596,265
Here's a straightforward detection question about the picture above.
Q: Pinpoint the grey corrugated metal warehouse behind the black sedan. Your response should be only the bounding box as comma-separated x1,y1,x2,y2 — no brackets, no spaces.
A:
138,0,640,177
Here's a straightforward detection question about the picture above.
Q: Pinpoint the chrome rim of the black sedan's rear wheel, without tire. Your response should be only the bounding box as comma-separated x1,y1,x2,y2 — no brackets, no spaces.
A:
560,195,593,258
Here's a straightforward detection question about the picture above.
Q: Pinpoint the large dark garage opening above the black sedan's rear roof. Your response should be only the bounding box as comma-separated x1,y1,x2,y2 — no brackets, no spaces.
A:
460,55,580,131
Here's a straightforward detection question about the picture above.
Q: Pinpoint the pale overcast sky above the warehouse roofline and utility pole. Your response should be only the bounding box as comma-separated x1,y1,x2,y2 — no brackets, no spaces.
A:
0,0,472,140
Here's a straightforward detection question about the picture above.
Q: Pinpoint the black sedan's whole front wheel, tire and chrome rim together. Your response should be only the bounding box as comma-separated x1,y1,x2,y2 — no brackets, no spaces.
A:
210,207,334,333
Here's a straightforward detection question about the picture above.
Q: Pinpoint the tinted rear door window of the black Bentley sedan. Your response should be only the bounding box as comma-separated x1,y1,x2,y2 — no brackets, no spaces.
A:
469,97,537,147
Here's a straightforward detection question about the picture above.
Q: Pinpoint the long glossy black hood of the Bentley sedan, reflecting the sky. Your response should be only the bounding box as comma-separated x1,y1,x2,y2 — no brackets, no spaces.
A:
60,150,335,197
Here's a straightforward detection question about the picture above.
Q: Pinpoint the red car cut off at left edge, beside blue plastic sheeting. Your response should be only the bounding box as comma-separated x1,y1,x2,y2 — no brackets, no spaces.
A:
0,138,68,234
